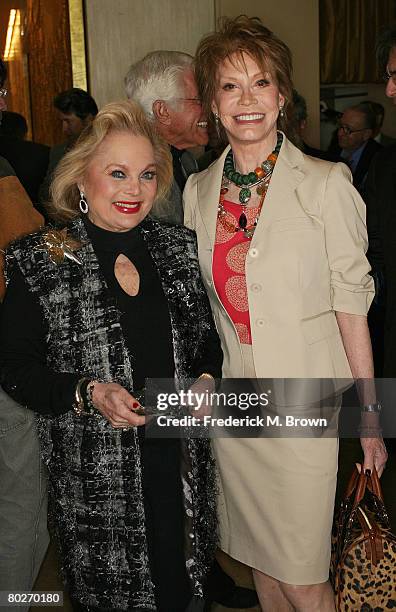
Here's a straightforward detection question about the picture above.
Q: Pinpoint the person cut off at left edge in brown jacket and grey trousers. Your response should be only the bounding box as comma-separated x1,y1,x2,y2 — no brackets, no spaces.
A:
0,59,49,612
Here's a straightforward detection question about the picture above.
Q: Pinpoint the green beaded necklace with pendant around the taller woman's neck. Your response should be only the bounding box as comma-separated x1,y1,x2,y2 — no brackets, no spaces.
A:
223,132,283,204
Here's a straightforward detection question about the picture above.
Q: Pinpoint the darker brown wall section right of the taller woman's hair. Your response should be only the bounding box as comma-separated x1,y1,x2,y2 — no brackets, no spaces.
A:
216,0,320,146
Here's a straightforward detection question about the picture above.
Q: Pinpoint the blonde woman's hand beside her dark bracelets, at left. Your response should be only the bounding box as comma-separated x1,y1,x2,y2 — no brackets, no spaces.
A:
92,382,146,429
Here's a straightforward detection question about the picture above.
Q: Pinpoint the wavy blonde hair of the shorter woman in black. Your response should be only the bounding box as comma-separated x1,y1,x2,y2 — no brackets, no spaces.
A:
50,100,173,221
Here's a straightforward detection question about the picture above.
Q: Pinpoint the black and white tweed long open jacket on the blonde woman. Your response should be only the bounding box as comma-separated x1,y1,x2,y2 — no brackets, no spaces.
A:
7,218,216,610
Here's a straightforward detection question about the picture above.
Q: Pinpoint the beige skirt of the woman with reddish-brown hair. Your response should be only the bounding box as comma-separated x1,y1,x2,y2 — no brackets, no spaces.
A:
213,345,338,585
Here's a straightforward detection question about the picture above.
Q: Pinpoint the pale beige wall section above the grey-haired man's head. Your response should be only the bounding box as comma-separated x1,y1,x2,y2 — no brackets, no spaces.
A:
86,0,215,107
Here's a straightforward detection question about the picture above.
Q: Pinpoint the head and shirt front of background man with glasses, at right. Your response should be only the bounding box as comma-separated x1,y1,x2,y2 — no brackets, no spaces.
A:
338,103,381,193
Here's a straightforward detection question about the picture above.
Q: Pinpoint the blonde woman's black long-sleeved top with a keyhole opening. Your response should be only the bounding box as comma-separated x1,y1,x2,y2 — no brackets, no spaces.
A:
0,219,221,414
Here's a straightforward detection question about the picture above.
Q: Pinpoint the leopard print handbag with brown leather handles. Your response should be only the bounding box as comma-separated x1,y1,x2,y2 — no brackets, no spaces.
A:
330,467,396,612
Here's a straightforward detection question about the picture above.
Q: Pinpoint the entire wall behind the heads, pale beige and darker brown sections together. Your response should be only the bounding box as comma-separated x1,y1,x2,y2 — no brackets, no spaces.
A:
86,0,319,146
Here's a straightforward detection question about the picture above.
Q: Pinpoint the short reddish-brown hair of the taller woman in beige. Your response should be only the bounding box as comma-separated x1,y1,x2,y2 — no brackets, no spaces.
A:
195,15,293,142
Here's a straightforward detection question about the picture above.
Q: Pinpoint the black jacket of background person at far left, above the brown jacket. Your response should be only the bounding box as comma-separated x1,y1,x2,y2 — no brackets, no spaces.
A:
0,136,50,203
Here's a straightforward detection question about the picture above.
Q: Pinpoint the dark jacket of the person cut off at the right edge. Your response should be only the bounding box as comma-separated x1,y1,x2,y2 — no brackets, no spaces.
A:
364,145,396,377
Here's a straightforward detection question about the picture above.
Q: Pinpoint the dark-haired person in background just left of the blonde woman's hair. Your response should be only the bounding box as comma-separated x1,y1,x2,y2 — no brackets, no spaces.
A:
39,87,98,209
